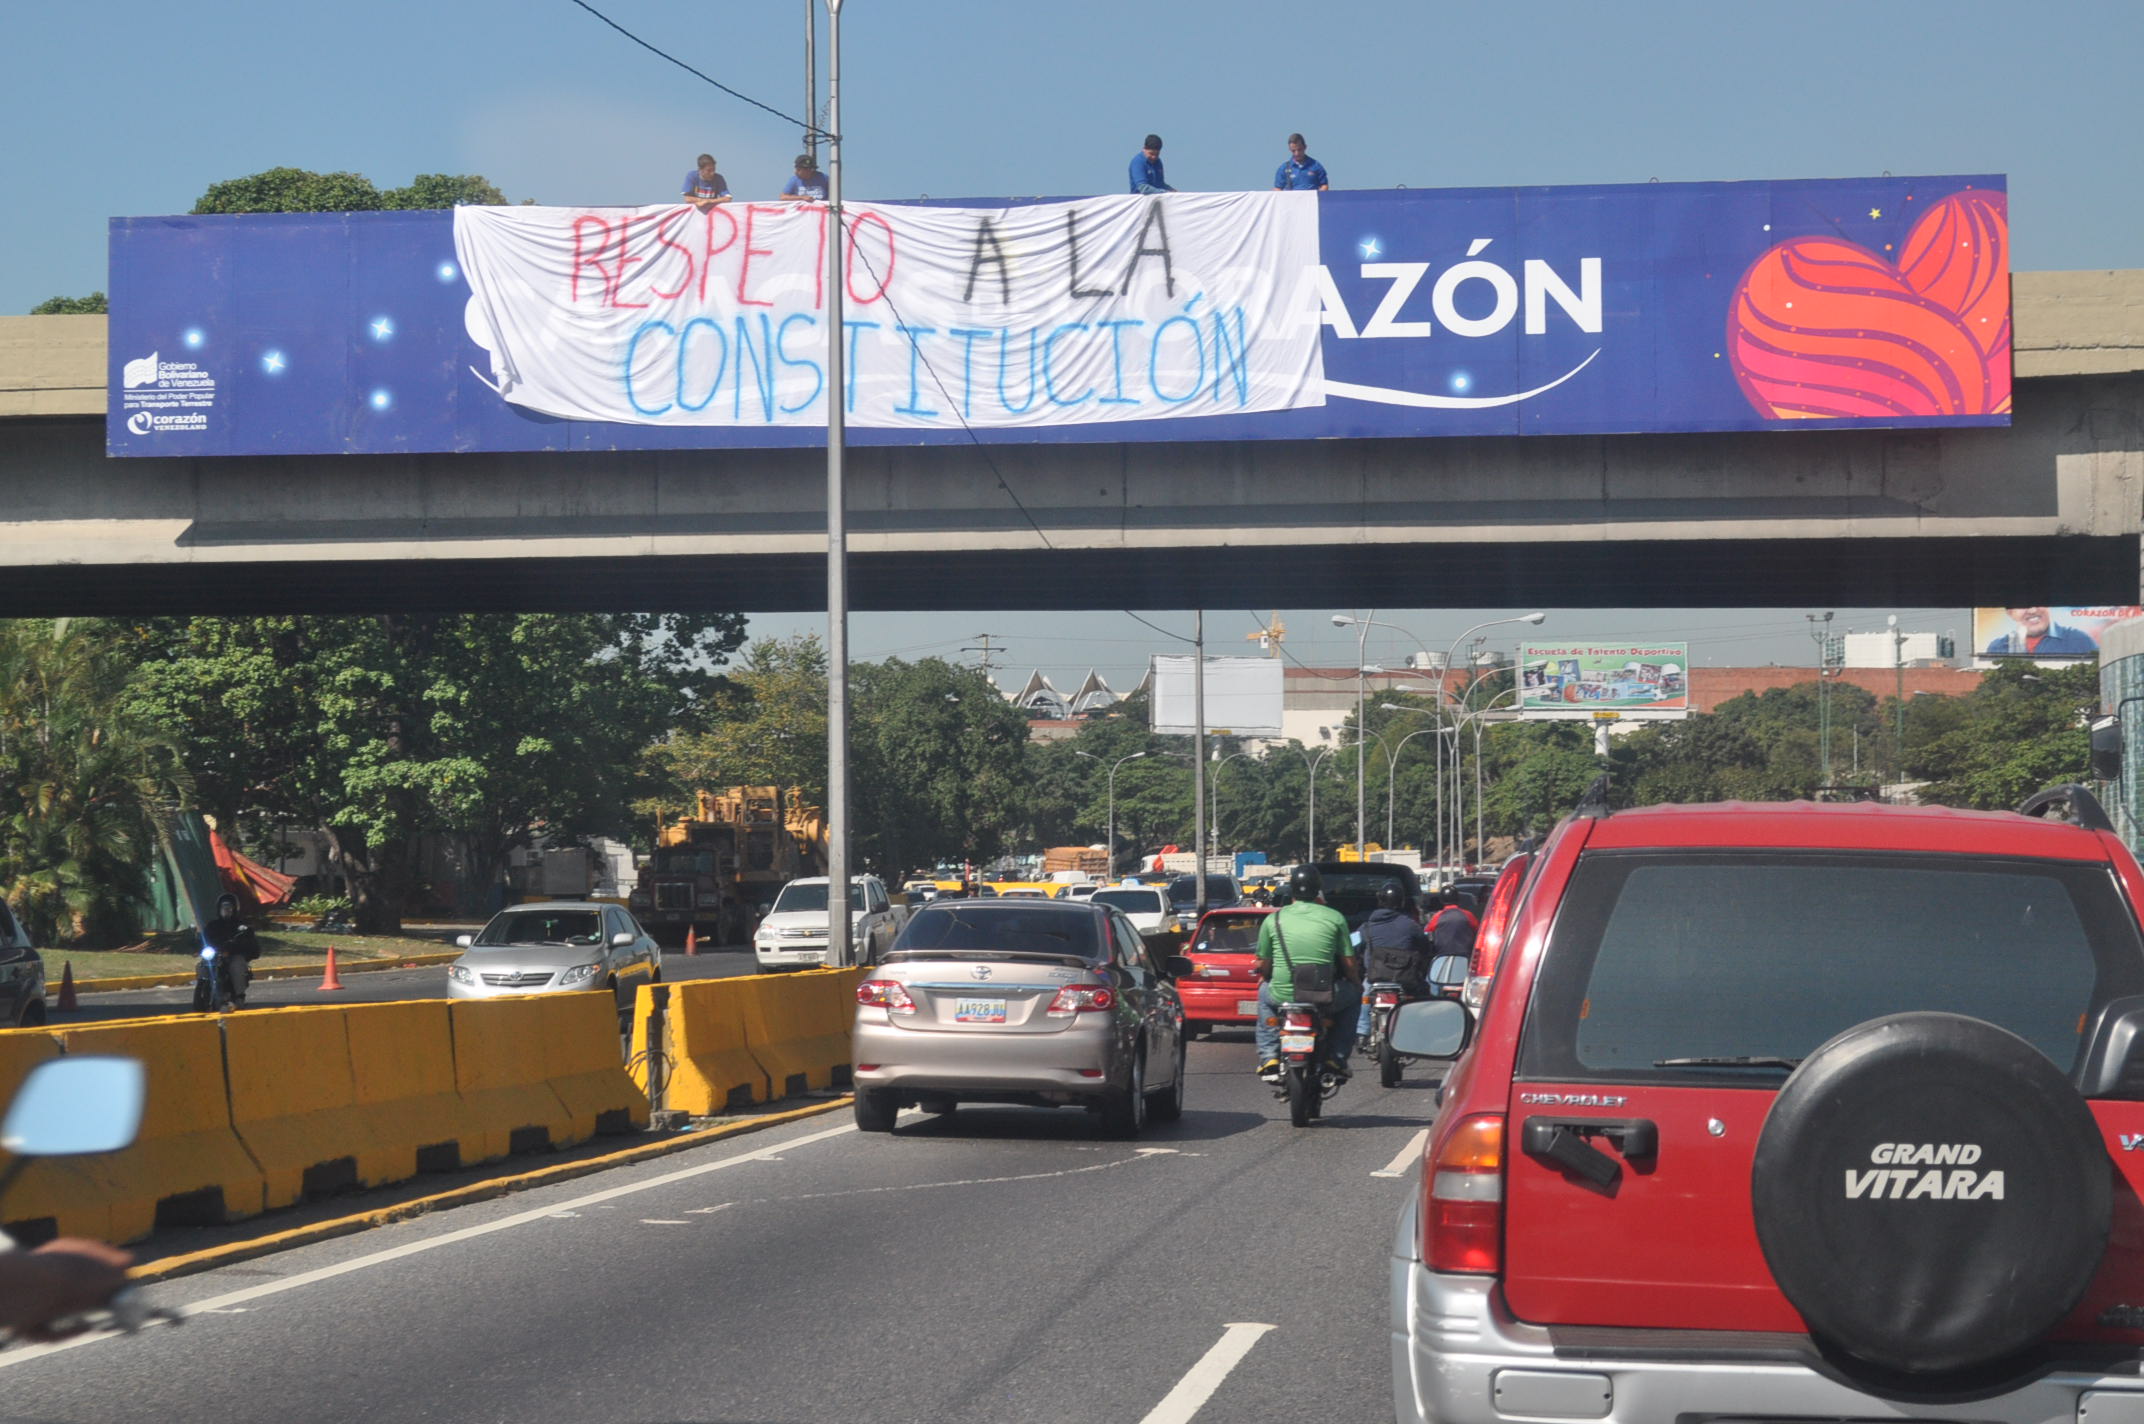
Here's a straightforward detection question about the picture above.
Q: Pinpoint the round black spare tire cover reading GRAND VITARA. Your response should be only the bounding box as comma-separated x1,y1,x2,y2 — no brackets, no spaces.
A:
1750,1014,2114,1373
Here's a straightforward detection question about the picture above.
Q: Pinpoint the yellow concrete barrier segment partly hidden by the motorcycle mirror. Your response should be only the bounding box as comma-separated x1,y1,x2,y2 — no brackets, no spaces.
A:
58,1017,266,1242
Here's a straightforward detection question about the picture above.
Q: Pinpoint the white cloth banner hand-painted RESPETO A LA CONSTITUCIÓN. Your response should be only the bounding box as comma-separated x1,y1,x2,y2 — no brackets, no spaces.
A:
455,193,1325,429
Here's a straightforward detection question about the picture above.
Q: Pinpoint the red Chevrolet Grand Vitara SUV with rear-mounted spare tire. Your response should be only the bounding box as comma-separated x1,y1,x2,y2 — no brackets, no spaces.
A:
1391,787,2144,1424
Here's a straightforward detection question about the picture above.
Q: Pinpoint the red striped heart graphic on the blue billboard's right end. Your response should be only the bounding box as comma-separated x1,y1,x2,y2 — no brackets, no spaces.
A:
1728,191,2011,420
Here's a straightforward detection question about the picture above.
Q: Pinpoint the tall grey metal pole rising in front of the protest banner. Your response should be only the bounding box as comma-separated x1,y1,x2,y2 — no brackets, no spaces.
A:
825,0,855,965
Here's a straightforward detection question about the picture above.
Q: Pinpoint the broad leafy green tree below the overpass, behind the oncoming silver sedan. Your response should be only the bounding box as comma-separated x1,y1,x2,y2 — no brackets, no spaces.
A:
129,613,742,933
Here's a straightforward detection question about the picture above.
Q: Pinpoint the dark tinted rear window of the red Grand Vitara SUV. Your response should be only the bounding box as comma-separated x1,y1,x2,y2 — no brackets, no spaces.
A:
1520,851,2144,1087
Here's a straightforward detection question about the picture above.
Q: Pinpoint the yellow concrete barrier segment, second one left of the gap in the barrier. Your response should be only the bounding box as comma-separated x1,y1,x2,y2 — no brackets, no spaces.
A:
340,999,485,1184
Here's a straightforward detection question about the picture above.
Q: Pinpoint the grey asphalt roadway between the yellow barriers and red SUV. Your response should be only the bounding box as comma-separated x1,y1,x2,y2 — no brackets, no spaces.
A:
0,1036,1434,1424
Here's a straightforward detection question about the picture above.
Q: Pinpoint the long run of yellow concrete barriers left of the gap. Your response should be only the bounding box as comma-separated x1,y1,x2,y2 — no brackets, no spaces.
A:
0,991,647,1244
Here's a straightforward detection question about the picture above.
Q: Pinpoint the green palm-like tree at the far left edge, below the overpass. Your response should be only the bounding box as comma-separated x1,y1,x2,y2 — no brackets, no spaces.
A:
0,622,187,944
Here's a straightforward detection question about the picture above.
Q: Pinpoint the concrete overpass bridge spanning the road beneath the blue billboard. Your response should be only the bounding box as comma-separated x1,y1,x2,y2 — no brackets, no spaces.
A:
0,270,2144,615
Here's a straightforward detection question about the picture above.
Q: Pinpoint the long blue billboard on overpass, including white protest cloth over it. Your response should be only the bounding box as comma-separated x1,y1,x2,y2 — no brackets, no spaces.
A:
107,176,2011,457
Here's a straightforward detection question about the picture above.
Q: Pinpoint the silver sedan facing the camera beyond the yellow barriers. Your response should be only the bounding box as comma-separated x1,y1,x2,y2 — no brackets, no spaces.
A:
446,901,662,999
